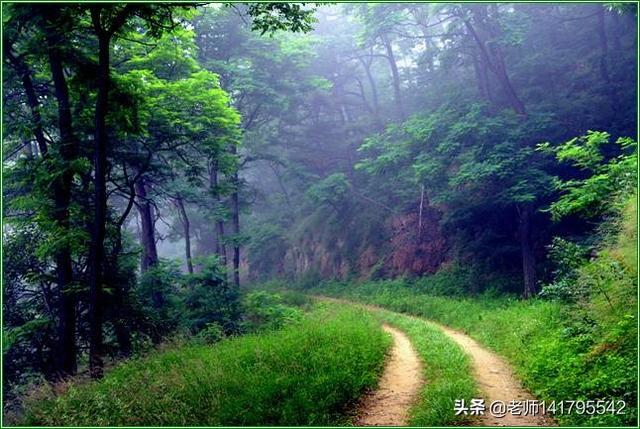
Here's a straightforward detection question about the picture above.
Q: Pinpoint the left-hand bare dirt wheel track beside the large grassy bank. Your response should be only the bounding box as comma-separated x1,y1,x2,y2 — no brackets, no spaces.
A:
355,325,423,426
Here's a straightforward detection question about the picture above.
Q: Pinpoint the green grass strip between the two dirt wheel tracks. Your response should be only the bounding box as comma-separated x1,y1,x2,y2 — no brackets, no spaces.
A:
375,310,477,426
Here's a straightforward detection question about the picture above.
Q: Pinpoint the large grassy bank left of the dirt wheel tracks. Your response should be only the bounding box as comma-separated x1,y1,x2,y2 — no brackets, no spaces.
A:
24,306,390,426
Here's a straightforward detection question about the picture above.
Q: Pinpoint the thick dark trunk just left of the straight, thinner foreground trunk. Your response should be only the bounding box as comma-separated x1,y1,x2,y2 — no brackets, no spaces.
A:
43,23,78,376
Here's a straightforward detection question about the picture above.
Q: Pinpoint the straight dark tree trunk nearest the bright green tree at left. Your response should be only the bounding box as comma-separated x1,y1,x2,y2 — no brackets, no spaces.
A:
89,30,111,378
